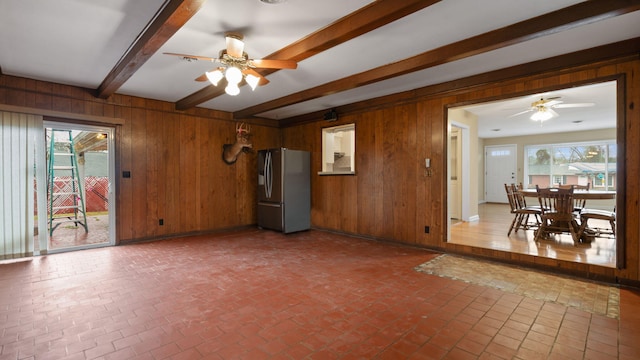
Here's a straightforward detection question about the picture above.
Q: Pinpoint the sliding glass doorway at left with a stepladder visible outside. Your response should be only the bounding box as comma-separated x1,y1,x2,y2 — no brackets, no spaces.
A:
43,121,115,253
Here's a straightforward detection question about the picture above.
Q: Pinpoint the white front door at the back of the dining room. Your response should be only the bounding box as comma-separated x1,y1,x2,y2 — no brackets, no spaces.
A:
484,145,517,203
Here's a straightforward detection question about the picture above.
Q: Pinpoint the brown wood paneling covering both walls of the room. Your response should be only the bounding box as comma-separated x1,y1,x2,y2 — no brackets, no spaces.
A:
0,57,640,282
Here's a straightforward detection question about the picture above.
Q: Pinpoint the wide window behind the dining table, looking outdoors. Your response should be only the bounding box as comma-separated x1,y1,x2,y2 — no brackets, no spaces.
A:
525,140,618,191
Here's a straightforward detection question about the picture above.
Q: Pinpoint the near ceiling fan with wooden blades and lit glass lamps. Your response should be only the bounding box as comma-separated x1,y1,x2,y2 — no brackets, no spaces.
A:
164,32,298,96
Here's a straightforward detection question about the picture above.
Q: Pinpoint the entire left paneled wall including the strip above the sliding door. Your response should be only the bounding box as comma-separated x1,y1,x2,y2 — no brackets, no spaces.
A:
0,75,280,242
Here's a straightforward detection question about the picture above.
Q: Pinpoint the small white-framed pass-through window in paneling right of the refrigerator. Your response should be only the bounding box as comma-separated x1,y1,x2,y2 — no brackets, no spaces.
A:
318,124,356,175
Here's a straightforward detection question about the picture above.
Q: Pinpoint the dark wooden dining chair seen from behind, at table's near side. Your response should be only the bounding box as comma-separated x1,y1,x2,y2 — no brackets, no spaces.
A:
534,185,580,244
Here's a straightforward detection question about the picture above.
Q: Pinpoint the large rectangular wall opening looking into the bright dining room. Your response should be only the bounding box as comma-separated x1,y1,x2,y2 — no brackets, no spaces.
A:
447,80,624,268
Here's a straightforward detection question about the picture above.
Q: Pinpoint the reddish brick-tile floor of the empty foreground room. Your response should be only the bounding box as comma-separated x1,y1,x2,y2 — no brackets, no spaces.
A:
0,229,640,359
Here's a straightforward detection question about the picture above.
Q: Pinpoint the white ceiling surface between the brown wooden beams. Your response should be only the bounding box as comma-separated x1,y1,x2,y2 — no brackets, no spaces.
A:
0,0,640,135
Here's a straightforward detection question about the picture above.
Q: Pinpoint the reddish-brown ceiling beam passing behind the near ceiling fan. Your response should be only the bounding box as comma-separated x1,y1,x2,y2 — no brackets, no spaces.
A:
176,0,441,110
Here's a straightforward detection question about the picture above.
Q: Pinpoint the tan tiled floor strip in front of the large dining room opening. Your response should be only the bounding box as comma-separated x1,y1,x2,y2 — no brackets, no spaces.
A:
415,255,620,319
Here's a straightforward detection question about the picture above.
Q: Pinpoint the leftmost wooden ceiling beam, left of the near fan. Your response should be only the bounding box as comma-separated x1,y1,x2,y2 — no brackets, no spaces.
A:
96,0,206,99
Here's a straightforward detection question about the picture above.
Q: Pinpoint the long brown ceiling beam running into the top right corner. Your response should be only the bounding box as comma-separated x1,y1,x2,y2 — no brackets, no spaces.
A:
234,0,640,119
